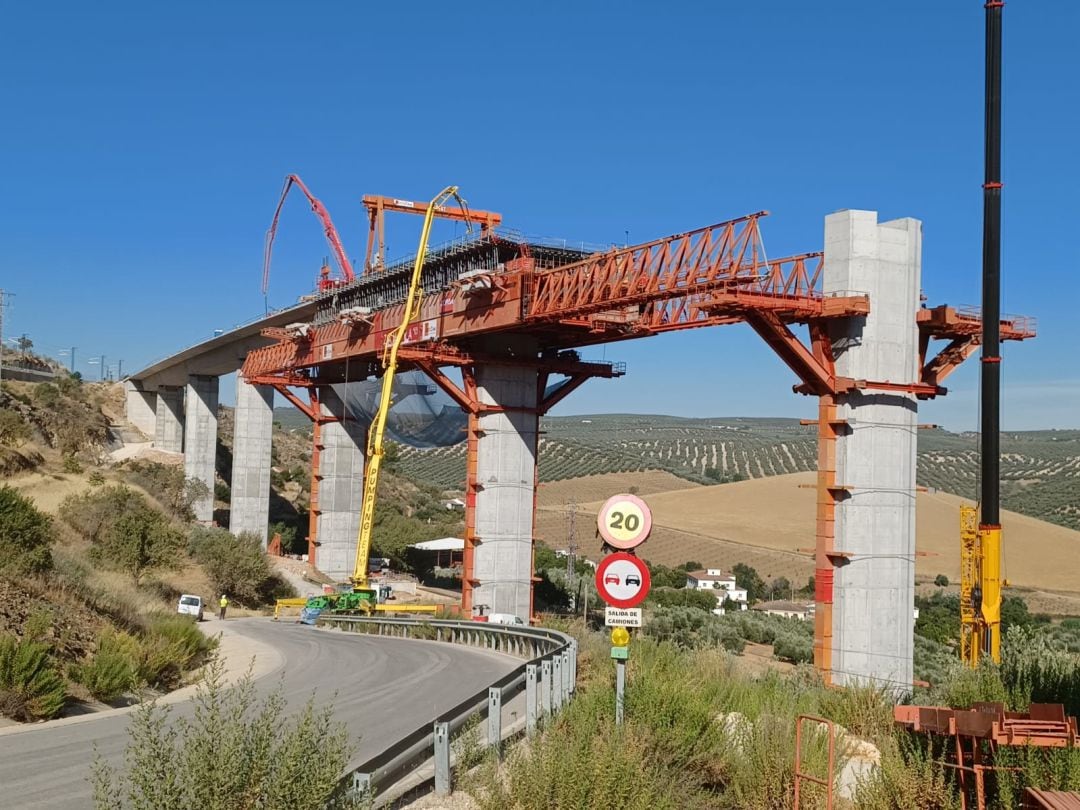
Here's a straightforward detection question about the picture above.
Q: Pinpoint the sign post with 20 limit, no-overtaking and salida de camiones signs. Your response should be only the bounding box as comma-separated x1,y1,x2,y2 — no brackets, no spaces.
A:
596,495,652,726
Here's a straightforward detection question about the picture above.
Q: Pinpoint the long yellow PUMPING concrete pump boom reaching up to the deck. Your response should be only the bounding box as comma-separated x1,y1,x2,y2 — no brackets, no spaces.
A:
352,186,471,591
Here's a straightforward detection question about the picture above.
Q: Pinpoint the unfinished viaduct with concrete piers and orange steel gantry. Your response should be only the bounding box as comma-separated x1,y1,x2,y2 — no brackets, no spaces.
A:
127,199,1035,688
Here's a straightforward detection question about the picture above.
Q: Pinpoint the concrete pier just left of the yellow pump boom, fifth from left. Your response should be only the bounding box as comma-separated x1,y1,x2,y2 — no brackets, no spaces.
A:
315,386,367,581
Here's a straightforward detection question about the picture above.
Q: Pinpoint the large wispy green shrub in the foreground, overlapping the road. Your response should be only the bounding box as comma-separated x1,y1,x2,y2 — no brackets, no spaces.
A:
92,662,360,810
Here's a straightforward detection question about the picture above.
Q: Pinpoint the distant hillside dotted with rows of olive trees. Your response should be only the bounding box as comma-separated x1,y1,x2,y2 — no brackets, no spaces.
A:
388,415,1080,530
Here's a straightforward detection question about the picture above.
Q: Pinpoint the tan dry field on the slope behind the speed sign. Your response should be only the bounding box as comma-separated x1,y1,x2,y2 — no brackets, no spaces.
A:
537,472,1080,593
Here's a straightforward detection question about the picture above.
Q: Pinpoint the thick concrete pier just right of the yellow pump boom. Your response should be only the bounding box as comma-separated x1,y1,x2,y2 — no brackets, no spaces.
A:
472,365,539,622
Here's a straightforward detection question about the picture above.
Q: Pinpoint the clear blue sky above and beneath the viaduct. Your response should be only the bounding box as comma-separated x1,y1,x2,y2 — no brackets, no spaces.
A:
0,0,1080,430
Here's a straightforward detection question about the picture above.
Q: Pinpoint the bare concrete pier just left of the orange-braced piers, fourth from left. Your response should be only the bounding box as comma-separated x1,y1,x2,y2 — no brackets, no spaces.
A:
229,376,273,548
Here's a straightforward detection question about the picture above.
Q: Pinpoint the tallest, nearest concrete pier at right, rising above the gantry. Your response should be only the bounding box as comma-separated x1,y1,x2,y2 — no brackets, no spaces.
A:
824,211,922,691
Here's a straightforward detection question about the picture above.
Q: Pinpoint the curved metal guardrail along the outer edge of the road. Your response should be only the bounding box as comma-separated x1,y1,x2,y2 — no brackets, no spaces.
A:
319,616,578,804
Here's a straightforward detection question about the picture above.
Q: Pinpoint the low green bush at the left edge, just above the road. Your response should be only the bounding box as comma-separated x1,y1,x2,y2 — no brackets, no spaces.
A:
0,634,67,720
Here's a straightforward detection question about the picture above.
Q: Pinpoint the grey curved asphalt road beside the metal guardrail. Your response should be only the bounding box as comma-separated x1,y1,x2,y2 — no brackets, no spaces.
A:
0,619,521,810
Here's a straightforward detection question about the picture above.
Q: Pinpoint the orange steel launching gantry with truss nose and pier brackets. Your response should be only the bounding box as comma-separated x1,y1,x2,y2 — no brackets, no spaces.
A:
242,198,1035,675
